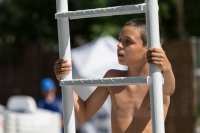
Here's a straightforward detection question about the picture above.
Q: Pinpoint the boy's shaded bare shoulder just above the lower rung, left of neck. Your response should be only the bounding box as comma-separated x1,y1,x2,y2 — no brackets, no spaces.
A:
104,69,127,78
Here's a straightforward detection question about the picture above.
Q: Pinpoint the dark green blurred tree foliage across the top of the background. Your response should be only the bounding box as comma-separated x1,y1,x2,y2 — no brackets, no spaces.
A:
0,0,200,51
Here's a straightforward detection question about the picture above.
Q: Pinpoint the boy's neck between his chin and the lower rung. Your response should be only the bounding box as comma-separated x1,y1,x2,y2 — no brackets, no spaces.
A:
127,63,149,76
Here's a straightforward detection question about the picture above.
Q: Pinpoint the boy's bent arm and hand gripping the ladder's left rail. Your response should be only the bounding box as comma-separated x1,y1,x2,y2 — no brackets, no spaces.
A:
54,59,109,124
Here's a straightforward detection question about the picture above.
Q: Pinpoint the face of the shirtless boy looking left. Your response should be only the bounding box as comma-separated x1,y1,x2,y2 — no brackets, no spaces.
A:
117,26,146,67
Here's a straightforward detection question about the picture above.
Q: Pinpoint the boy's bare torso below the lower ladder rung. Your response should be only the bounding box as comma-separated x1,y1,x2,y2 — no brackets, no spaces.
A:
105,72,170,133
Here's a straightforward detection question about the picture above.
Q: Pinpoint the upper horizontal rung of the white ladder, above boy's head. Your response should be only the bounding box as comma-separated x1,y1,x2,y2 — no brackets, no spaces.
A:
55,3,146,19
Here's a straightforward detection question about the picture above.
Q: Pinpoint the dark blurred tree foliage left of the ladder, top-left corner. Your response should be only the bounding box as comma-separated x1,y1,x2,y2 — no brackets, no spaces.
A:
0,0,57,45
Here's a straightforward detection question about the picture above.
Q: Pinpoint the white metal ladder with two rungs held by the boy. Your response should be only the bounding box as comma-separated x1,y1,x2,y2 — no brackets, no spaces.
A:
55,0,165,133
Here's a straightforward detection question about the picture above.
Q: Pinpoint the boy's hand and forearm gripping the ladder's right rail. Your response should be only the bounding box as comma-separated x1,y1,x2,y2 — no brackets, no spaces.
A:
146,48,175,95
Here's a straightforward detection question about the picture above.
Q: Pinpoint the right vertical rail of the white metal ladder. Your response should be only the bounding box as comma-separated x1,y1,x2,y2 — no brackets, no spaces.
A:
146,0,165,133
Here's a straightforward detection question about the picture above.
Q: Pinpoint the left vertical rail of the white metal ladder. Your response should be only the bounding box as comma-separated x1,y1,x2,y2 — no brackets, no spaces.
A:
56,0,76,133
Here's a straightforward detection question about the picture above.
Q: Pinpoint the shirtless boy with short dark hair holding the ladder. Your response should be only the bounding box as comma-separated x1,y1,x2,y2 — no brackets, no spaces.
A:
54,19,175,133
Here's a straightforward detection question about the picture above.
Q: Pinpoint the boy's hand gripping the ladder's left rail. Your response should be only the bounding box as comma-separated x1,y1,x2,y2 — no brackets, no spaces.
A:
54,59,73,80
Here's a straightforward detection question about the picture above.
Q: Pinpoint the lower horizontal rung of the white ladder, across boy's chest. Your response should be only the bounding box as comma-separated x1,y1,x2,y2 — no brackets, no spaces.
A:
60,76,149,86
